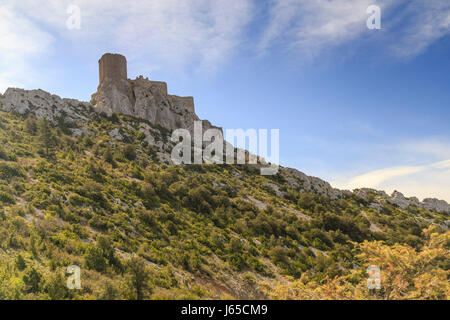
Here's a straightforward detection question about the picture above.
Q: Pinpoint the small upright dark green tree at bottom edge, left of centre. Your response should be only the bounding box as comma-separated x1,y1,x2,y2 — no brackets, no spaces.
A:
127,256,150,300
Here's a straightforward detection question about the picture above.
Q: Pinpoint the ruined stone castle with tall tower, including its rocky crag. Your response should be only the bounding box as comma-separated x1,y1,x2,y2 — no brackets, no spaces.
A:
91,53,211,131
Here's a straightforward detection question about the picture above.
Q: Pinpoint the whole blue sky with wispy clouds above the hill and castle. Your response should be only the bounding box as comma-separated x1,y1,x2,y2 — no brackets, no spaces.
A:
0,0,450,201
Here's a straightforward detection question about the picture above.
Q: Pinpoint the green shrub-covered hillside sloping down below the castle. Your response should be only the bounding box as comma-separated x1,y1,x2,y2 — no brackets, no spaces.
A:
0,91,449,299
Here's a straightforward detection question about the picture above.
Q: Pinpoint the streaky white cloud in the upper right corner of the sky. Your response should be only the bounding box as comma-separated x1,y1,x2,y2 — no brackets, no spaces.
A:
258,0,450,58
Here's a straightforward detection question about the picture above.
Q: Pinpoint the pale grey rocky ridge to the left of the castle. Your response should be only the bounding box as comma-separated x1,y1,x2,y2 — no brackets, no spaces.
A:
2,88,91,125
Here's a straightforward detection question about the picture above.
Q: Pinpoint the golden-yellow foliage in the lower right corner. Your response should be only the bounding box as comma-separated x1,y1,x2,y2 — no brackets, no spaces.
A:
262,226,450,300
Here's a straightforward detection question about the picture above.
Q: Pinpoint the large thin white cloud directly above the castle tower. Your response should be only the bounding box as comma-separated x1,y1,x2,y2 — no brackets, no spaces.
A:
8,0,253,72
